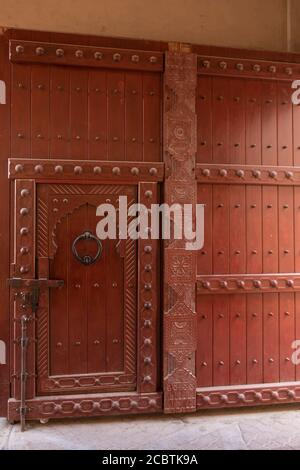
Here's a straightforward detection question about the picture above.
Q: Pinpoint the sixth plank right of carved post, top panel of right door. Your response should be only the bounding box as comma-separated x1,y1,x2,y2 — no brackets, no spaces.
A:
277,81,293,166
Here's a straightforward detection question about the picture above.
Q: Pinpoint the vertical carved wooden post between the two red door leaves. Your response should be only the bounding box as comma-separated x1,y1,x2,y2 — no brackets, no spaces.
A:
164,45,197,413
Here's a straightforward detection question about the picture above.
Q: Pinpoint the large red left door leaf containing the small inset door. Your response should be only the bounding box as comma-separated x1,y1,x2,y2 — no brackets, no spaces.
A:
8,32,164,420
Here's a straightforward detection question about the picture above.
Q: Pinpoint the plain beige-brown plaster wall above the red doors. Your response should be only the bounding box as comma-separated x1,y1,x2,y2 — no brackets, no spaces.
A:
0,0,290,50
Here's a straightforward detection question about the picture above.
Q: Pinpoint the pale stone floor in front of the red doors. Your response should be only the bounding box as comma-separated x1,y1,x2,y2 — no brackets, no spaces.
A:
0,405,300,450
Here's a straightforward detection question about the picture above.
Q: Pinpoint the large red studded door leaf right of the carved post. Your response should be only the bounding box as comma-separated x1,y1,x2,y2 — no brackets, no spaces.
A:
197,54,299,408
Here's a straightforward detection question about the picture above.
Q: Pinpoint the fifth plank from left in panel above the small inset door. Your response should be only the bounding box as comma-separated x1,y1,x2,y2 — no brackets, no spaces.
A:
88,70,107,160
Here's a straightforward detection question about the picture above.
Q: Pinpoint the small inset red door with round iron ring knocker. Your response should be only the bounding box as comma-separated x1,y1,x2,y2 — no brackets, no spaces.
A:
36,184,137,394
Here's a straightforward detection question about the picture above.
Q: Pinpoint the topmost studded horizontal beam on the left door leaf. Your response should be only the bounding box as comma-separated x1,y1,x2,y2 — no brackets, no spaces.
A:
9,39,164,72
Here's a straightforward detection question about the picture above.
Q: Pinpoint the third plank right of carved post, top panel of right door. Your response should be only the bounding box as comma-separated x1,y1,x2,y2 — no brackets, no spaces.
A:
229,79,246,164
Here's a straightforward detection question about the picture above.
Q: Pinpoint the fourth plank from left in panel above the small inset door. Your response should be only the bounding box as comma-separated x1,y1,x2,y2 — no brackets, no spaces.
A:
70,68,88,160
